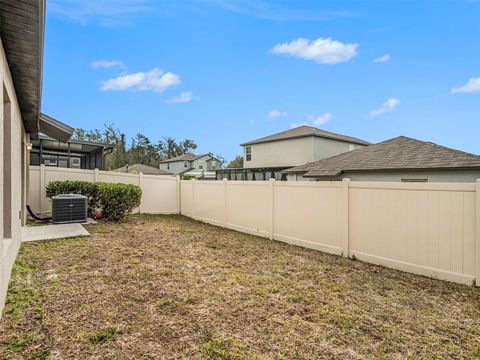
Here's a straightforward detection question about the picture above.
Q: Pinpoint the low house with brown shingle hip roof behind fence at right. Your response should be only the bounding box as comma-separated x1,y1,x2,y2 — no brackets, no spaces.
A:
283,136,480,182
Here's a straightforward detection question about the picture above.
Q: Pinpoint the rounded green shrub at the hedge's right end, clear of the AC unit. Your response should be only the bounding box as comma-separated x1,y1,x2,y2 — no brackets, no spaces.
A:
98,183,142,221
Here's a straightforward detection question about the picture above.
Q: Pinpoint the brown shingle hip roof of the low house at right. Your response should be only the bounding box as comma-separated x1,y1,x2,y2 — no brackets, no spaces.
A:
283,136,480,177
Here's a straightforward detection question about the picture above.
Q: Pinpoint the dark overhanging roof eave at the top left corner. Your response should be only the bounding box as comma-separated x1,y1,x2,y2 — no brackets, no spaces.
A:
0,0,45,138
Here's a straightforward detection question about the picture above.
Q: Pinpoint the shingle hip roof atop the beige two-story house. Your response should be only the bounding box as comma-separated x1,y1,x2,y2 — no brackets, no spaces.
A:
240,125,370,146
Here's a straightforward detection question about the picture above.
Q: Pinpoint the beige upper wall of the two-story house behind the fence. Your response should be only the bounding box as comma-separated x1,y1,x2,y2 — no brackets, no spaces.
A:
243,136,363,169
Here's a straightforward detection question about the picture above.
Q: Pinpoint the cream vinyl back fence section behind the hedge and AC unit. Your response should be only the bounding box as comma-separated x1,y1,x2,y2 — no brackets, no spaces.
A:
29,165,180,214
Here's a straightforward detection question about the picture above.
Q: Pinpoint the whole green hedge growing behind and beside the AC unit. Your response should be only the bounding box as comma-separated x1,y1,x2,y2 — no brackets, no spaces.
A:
46,180,142,221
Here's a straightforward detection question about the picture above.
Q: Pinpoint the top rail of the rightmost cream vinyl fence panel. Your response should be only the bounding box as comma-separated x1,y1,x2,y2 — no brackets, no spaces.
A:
349,181,475,192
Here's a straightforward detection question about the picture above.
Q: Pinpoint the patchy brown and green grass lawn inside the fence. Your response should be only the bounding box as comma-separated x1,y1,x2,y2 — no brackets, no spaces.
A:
0,215,480,359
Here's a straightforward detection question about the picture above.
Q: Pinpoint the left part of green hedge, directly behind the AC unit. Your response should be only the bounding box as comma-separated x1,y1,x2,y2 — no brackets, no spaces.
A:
45,180,100,217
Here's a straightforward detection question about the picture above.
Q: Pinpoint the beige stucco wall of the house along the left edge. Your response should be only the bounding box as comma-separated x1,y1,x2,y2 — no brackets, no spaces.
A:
0,38,26,312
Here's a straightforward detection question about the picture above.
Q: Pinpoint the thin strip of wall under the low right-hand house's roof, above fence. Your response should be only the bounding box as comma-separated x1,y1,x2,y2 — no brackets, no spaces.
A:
287,170,480,183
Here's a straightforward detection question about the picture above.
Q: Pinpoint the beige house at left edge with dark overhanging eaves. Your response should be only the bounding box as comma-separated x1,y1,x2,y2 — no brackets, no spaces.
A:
0,0,72,313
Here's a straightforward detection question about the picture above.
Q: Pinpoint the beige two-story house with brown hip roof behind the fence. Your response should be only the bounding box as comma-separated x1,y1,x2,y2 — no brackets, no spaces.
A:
217,125,370,180
